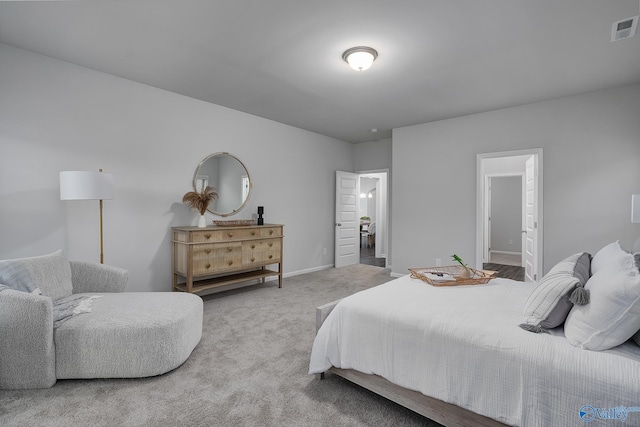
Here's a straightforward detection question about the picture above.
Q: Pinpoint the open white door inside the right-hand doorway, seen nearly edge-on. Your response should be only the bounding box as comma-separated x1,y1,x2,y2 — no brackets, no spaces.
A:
523,156,538,282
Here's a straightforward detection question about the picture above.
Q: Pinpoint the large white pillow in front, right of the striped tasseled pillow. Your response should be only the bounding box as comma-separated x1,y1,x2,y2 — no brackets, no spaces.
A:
564,267,640,350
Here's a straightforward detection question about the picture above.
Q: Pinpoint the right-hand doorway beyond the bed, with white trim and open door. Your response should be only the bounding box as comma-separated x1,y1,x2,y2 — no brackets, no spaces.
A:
476,149,543,281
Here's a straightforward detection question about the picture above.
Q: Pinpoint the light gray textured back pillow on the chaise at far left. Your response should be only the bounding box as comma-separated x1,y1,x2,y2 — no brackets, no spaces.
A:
0,251,73,301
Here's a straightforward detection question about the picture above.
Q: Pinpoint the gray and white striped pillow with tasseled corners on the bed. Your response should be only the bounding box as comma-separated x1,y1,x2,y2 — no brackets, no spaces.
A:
520,252,591,332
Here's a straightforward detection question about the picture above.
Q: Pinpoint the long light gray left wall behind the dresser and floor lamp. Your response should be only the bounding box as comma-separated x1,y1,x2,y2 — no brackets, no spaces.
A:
0,44,354,291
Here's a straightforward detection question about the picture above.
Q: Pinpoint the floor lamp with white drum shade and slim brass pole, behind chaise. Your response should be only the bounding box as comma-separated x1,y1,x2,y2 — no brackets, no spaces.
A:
60,169,113,264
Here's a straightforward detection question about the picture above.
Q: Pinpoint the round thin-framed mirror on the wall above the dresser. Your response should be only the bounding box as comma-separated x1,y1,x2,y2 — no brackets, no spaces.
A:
193,153,252,216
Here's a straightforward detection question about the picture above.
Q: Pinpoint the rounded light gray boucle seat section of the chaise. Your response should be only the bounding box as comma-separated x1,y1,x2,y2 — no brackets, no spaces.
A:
54,292,203,379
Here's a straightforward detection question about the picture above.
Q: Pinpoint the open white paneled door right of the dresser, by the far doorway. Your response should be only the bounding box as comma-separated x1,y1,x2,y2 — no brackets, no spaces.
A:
334,171,360,268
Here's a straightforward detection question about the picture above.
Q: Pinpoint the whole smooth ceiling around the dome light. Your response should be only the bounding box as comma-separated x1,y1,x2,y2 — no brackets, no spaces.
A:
0,0,640,142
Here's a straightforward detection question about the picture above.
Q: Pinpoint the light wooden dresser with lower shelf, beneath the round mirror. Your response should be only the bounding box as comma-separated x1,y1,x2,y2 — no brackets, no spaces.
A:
171,224,284,293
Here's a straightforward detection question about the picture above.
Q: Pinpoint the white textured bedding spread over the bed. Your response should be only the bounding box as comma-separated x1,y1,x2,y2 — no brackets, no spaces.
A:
309,275,640,426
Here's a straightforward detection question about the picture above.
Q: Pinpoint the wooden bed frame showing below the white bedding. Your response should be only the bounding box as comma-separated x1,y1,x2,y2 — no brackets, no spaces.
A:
316,301,505,427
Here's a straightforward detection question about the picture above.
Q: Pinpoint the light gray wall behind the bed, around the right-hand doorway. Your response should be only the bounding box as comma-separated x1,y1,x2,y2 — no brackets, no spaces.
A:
391,85,640,274
